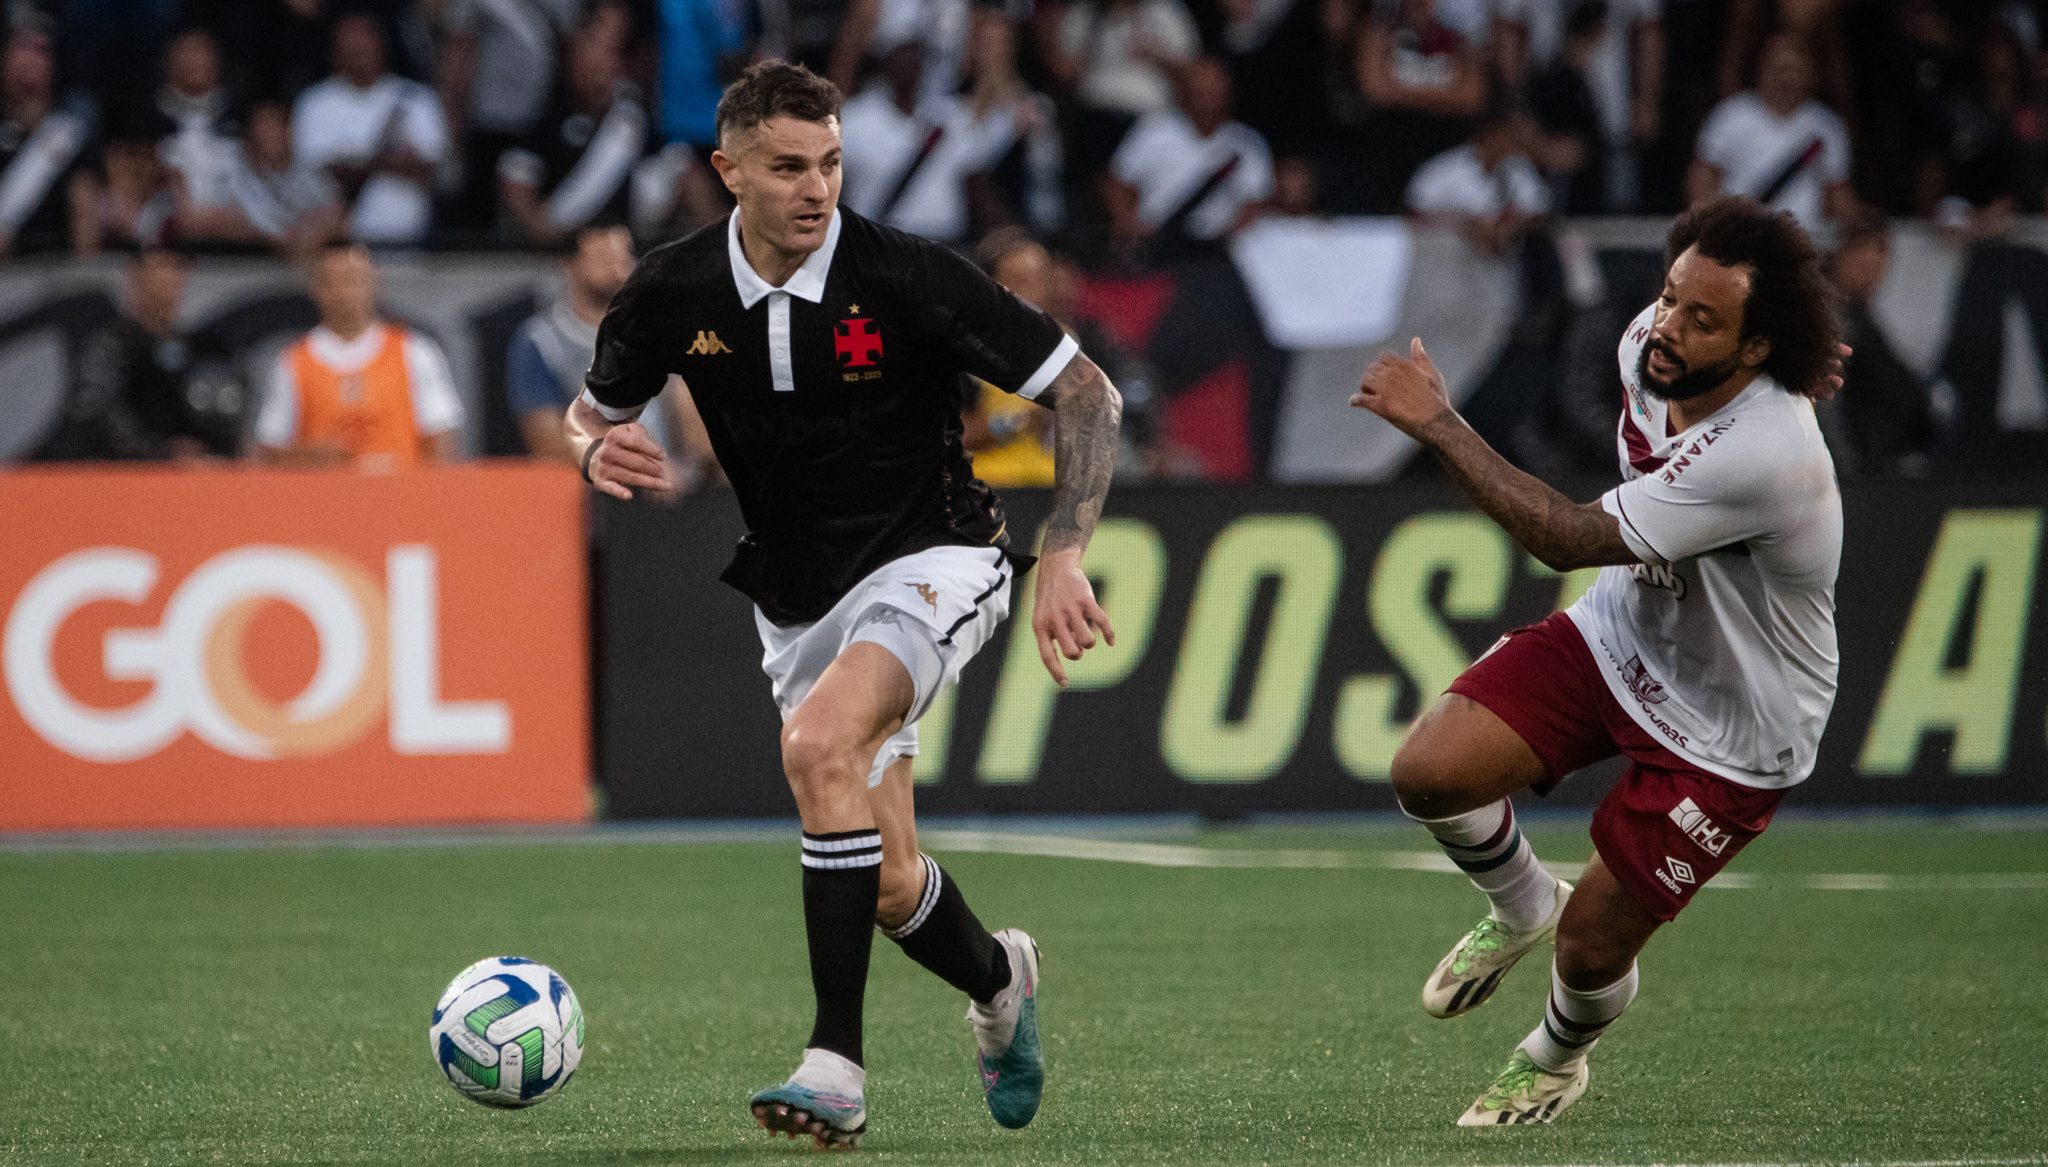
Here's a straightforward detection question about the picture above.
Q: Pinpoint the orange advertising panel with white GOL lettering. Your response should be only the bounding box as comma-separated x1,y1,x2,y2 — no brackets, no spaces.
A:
0,465,590,831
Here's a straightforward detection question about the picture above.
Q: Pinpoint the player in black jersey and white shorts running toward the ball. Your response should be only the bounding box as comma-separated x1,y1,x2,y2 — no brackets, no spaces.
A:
567,61,1122,1147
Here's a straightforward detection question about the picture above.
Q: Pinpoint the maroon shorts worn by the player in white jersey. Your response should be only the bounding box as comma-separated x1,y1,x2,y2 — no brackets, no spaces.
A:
1450,612,1784,921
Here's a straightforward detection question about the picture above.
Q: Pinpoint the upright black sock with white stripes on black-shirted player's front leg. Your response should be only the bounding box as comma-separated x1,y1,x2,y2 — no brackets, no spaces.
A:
803,827,883,1065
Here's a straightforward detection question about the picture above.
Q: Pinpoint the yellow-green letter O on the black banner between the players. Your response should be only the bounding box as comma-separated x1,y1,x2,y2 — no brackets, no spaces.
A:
1159,514,1343,782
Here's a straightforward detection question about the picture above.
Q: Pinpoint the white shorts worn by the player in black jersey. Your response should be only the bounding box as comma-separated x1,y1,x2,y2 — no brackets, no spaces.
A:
754,547,1012,786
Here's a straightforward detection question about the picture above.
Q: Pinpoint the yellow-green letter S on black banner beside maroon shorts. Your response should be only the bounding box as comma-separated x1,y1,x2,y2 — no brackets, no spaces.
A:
1333,514,1515,782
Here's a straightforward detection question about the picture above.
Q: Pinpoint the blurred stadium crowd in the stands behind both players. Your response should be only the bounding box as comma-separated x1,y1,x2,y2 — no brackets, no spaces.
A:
0,0,2048,485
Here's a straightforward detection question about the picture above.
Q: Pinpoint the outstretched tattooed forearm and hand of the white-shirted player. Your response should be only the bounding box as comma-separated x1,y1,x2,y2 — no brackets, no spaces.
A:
1352,338,1636,571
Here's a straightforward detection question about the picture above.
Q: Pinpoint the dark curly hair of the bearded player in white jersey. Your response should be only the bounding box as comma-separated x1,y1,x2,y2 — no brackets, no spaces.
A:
1665,197,1841,401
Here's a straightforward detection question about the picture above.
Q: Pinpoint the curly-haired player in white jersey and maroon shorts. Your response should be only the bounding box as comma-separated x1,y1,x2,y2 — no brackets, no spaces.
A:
1352,199,1843,1126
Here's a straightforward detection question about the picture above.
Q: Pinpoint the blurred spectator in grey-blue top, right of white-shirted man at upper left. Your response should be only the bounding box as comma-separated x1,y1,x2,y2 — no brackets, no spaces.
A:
436,0,584,229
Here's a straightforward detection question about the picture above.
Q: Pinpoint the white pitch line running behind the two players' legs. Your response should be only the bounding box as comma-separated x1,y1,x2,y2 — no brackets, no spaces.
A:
924,831,2048,888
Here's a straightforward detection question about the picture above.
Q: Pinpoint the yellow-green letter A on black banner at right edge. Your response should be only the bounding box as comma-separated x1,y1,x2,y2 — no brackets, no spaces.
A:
1855,510,2042,774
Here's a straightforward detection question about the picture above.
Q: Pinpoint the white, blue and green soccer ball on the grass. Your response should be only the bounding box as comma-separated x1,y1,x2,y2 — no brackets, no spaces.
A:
426,956,584,1108
